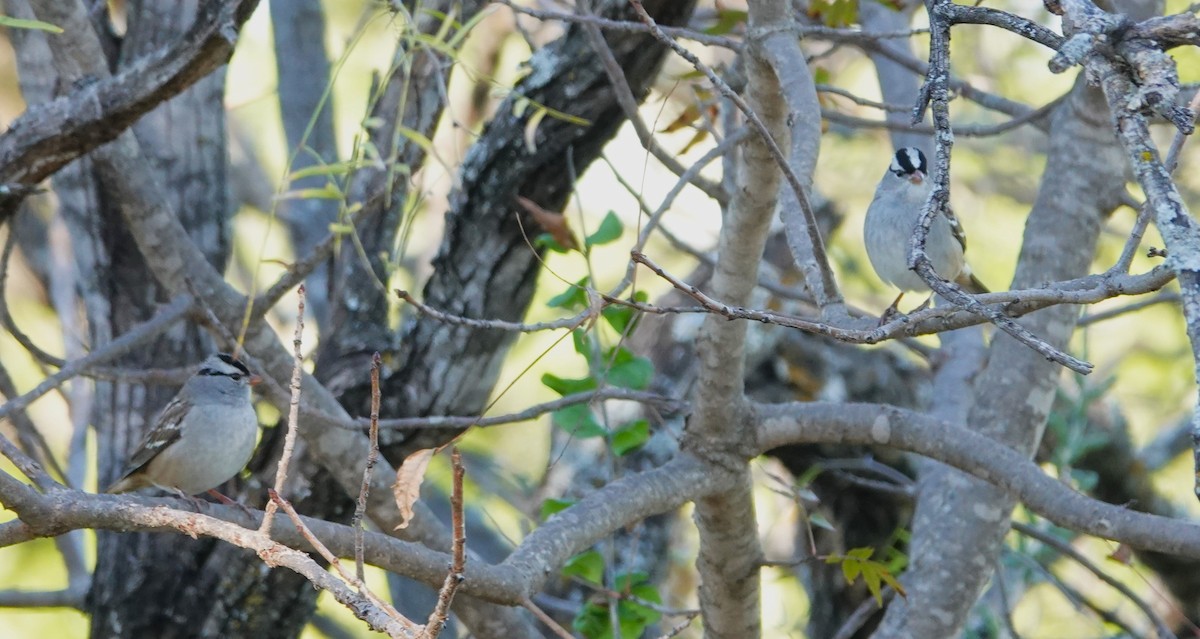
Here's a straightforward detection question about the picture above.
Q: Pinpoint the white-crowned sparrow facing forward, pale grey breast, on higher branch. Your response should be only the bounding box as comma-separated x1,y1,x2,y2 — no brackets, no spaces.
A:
863,147,988,311
